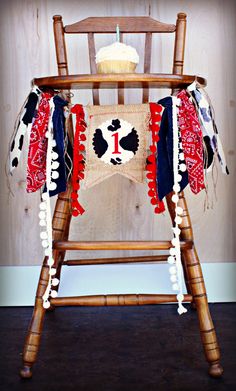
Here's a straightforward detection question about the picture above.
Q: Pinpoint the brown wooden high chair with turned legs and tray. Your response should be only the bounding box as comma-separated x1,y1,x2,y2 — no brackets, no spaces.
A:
20,13,223,378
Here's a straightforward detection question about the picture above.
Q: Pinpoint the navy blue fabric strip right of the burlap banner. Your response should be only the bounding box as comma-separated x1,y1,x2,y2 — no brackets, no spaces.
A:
157,97,188,200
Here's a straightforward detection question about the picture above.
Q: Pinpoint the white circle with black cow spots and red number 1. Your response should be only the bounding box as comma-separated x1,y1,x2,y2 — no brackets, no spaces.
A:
93,118,139,165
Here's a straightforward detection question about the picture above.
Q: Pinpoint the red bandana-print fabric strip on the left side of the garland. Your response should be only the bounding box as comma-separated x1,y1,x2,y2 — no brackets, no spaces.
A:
26,92,53,193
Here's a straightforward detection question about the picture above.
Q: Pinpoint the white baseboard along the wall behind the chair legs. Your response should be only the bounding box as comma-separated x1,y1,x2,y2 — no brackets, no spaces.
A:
0,262,236,306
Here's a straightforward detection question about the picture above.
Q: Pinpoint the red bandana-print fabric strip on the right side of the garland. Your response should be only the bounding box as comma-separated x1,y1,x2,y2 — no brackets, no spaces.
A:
177,90,205,194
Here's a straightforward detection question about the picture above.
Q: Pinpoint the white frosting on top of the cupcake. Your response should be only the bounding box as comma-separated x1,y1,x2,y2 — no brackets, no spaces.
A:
96,42,139,64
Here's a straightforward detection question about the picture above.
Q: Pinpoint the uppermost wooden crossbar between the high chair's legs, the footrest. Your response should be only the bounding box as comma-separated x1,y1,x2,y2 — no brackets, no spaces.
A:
53,240,193,251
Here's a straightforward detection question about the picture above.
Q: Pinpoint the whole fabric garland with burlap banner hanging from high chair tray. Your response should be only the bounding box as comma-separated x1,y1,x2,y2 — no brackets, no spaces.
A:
9,83,228,314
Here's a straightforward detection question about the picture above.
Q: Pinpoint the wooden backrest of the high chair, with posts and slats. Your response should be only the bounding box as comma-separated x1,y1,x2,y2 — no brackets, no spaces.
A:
53,13,186,105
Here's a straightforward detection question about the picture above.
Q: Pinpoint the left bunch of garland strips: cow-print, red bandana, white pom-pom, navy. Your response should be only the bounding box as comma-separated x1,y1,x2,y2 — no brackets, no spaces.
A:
10,89,72,308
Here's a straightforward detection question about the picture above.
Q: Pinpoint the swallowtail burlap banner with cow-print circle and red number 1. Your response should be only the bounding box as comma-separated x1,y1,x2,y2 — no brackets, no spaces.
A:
83,104,150,189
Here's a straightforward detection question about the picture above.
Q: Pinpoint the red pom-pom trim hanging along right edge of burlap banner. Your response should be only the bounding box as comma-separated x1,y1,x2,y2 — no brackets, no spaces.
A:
146,103,165,213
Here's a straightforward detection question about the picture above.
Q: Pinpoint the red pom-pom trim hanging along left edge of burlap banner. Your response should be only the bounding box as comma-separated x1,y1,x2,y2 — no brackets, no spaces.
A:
71,104,86,216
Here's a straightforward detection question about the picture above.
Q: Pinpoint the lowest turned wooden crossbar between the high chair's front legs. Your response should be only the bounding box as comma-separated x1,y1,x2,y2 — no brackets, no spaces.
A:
51,294,193,307
